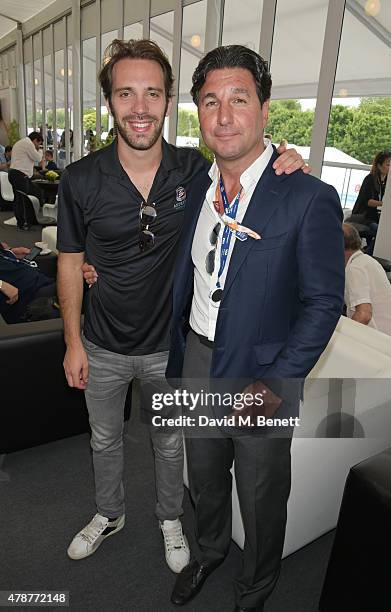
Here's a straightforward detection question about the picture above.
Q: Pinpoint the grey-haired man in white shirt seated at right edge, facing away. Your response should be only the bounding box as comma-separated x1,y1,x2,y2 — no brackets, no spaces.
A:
343,223,391,335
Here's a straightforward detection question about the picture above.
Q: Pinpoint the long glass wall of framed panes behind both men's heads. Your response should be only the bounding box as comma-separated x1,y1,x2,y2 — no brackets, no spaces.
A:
12,0,391,170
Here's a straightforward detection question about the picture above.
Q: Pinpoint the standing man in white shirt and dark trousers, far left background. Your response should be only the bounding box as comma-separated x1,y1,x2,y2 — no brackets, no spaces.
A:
9,132,44,206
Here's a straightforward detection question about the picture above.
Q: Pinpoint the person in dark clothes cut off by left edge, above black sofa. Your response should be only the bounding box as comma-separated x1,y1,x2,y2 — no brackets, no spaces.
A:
0,242,59,323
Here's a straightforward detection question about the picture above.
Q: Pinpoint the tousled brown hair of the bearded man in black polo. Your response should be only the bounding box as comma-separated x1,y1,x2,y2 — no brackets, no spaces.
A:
98,38,174,102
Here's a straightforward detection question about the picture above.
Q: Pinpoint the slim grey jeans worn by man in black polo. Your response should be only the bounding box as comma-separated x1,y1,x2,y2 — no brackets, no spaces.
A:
83,337,183,521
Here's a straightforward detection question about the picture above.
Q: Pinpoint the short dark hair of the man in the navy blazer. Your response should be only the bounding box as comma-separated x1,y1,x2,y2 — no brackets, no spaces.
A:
190,45,272,106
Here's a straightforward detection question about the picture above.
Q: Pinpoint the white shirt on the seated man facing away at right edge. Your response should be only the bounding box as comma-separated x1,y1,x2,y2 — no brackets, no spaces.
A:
345,251,391,335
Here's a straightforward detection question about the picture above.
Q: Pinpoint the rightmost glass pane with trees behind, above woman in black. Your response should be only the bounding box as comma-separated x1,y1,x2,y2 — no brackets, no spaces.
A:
322,2,391,209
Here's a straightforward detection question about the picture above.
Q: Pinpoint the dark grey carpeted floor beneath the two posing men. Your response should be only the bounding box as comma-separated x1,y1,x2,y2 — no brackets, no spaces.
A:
0,412,333,612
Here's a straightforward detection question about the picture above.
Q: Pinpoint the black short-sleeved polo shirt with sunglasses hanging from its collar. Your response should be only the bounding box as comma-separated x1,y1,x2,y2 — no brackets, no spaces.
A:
57,140,210,355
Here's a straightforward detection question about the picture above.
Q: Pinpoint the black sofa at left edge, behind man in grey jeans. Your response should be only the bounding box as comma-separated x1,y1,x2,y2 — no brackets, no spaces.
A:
0,319,132,455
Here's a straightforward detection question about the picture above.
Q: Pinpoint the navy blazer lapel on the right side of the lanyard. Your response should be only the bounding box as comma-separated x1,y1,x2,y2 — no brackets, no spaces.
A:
223,153,288,300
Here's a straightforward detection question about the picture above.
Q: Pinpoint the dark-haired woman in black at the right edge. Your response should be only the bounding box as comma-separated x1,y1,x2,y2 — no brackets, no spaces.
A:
352,151,391,255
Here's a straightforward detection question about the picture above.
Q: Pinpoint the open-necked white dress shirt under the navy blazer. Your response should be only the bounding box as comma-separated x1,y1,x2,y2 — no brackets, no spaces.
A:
190,140,273,341
